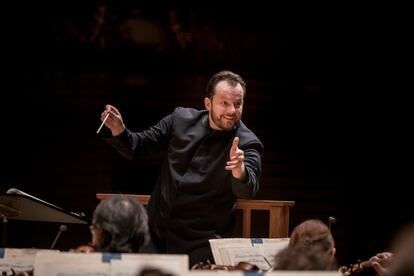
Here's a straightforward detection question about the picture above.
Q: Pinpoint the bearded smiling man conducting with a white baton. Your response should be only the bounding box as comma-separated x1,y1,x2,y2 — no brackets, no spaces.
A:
101,71,263,265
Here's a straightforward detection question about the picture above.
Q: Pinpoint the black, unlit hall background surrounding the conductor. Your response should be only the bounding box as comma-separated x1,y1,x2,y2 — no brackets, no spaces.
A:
0,1,414,274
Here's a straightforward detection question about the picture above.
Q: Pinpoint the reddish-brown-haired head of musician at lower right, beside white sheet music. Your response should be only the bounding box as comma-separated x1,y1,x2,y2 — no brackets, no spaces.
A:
289,219,336,256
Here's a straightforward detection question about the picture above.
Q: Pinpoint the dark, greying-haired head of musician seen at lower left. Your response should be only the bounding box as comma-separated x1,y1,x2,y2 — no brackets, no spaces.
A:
91,195,149,253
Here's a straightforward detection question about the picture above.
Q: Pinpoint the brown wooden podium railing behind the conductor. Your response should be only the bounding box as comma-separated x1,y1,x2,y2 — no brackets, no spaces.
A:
96,194,295,238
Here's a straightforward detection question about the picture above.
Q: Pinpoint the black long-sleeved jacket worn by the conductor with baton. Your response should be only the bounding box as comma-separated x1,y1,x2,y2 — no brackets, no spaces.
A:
106,107,263,254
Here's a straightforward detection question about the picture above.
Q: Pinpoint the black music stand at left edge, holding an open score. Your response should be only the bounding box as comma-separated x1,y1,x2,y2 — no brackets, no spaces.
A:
0,188,88,245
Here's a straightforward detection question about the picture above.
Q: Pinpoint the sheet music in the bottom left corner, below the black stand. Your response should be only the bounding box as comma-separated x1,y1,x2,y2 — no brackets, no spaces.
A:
0,248,57,275
